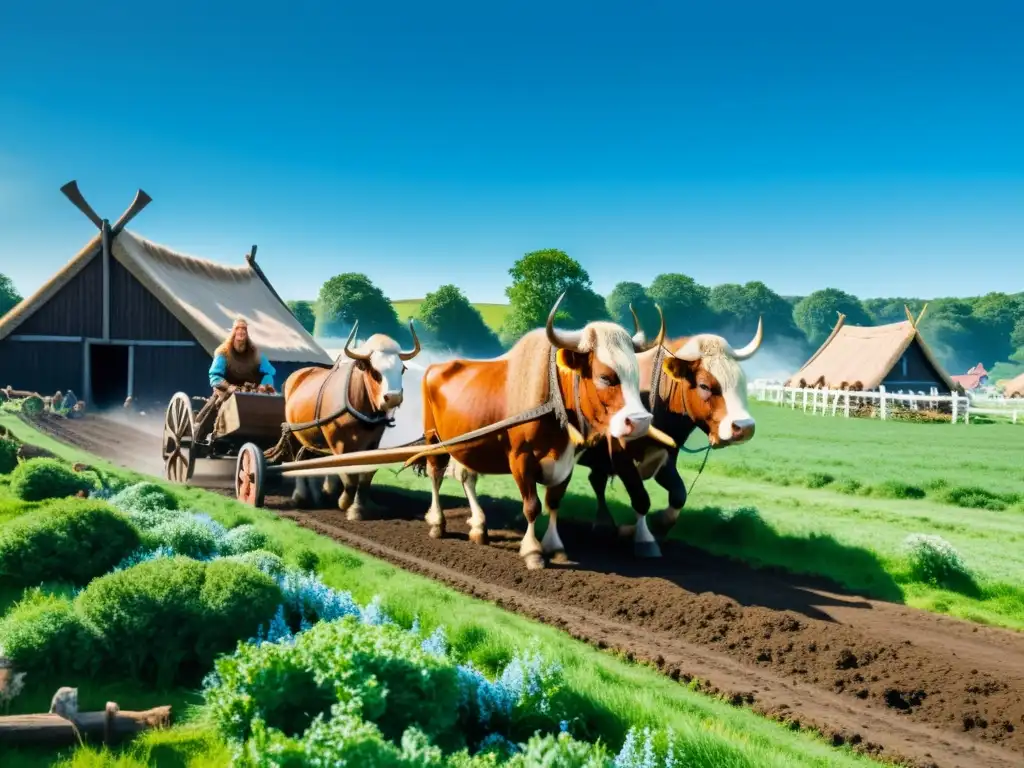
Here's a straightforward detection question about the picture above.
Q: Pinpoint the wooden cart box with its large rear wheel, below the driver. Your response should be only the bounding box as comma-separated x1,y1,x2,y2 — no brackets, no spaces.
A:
163,390,285,483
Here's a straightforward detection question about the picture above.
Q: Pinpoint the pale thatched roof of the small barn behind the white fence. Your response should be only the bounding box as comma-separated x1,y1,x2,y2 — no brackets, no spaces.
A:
786,309,956,391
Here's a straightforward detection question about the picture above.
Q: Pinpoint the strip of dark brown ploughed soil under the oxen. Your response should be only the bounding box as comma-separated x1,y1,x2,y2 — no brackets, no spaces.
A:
24,418,1024,767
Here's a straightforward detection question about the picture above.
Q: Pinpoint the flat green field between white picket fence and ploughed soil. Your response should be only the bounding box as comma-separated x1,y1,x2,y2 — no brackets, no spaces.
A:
375,402,1024,629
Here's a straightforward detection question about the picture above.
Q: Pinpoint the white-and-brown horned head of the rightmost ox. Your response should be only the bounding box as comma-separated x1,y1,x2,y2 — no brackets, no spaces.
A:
664,318,764,447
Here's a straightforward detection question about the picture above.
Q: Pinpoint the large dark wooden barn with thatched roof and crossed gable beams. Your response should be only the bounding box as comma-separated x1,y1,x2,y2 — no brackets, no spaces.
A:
0,181,332,408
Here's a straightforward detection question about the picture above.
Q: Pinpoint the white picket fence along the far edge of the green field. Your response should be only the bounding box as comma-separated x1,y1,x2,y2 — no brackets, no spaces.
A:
750,383,1024,424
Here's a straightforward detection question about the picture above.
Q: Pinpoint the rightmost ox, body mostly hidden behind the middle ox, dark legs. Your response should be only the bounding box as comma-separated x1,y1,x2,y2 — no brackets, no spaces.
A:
579,319,764,557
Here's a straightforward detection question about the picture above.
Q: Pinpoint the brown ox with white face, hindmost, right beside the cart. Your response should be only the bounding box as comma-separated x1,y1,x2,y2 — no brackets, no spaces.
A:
285,321,420,520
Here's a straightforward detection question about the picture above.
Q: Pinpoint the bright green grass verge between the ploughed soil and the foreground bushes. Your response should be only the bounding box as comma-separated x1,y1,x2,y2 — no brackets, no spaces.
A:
0,417,874,768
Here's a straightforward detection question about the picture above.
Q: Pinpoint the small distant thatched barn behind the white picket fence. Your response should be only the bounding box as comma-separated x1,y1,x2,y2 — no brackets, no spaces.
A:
786,305,956,394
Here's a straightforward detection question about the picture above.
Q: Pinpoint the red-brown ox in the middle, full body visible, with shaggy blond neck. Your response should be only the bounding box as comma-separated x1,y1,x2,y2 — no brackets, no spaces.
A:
411,297,665,569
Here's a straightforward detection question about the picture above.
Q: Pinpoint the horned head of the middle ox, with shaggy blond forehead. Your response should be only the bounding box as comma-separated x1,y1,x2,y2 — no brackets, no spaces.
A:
546,293,665,446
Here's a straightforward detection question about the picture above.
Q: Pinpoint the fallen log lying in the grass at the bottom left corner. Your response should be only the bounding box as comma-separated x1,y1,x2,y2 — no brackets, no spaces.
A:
0,701,171,746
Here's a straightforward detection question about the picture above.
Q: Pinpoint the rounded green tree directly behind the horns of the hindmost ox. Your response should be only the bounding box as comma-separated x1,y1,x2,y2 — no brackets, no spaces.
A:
316,272,400,339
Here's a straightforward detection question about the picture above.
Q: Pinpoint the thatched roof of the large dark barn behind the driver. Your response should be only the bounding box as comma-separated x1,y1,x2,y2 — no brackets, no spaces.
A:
0,229,333,365
